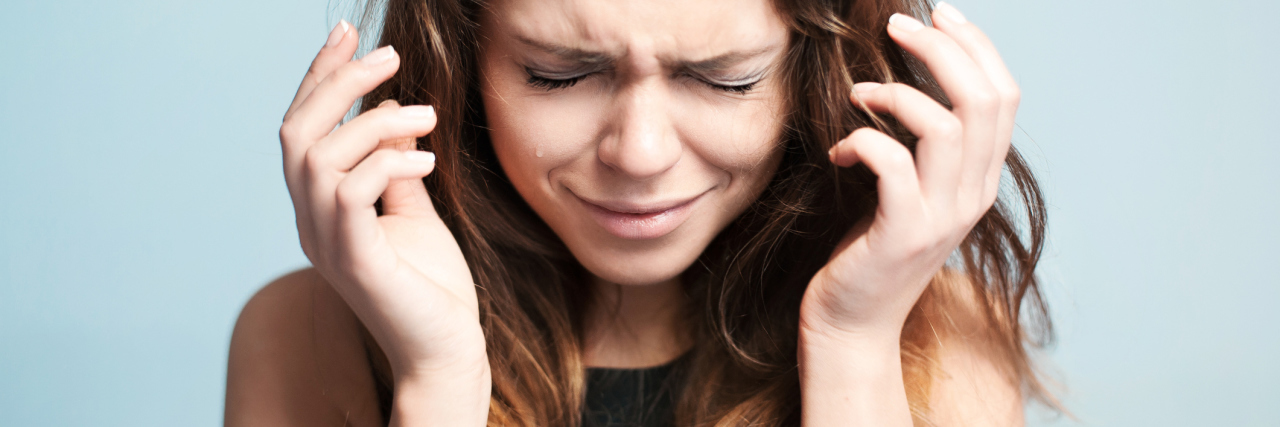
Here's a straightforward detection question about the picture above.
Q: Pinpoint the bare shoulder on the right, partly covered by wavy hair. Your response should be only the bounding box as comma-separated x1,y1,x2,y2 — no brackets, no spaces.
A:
929,275,1025,427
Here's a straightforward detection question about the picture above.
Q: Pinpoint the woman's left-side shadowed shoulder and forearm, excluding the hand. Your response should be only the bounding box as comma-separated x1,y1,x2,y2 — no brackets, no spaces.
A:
224,270,489,427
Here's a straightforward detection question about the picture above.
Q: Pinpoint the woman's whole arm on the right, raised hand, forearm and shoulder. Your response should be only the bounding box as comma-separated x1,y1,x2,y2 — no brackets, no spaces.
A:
799,4,1021,426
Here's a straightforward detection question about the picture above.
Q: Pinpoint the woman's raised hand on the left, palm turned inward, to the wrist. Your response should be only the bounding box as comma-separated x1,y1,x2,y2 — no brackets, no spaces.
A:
280,22,488,386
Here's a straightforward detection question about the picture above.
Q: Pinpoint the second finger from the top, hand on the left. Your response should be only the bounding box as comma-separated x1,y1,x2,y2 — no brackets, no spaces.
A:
280,46,399,152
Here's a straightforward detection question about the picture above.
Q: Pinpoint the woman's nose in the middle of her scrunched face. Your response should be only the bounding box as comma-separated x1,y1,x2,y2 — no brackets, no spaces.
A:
596,81,684,180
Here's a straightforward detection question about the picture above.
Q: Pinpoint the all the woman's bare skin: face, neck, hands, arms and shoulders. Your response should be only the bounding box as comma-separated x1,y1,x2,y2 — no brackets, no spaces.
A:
227,0,1021,426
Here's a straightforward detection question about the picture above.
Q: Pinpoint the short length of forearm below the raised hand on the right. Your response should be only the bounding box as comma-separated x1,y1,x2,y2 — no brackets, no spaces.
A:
799,329,911,427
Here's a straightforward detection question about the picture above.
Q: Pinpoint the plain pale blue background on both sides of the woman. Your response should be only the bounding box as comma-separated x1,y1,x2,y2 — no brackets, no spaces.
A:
0,0,1280,426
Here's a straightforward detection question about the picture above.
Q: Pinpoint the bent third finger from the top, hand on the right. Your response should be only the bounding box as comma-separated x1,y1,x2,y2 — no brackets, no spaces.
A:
852,83,964,206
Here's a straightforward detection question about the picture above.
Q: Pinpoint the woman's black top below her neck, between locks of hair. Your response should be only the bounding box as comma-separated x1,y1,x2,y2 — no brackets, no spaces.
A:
374,353,689,427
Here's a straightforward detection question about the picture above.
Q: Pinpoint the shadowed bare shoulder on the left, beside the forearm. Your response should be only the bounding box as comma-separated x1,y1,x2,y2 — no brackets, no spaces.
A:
225,268,381,426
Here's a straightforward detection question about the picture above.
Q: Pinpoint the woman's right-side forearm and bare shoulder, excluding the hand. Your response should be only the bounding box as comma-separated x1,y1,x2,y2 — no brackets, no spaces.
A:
800,275,1024,426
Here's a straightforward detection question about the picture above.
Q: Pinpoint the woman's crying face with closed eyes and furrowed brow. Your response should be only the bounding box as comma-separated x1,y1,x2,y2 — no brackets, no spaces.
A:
480,0,787,285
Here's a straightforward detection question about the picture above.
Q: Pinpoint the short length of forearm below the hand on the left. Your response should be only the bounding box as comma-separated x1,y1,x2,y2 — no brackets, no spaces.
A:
390,362,492,427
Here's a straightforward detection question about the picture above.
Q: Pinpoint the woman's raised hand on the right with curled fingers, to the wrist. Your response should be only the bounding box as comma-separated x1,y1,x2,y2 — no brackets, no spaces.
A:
801,5,1019,343
